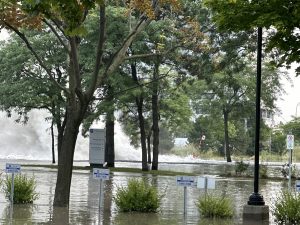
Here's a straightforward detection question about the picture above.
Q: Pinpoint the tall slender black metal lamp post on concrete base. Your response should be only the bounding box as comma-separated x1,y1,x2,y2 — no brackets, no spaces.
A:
248,27,265,205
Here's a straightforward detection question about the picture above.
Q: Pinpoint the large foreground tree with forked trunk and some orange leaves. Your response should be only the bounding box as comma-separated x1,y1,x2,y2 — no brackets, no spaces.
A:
0,0,178,206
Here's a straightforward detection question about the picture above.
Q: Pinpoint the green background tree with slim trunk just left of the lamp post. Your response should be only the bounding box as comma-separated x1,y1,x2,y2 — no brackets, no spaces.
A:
176,2,286,161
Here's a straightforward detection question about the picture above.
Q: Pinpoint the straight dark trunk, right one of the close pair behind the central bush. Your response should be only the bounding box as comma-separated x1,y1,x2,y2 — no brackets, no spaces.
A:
152,62,159,170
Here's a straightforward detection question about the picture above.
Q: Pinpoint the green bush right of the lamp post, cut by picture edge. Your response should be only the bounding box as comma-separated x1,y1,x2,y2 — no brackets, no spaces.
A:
272,191,300,225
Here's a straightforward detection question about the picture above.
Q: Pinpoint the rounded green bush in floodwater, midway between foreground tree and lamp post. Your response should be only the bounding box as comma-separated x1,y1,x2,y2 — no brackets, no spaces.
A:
114,179,161,212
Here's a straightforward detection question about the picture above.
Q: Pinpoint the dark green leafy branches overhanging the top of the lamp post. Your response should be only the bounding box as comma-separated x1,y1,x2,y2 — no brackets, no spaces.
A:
206,0,300,74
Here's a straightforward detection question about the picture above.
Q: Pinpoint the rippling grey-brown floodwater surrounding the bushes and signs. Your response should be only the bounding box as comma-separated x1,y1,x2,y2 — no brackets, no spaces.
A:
0,161,287,225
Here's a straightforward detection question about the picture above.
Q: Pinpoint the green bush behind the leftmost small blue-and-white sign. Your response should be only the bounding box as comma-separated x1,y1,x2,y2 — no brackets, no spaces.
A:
2,174,38,204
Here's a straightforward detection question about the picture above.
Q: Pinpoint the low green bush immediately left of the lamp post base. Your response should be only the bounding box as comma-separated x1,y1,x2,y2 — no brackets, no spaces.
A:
196,195,233,218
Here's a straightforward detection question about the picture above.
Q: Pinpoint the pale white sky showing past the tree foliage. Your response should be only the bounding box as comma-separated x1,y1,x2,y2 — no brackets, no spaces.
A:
0,30,300,124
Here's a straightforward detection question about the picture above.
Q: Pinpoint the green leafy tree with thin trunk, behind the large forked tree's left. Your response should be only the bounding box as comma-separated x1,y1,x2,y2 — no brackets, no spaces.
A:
0,32,67,163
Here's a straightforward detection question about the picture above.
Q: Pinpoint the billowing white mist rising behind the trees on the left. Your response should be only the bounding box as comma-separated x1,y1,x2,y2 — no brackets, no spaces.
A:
0,110,141,160
